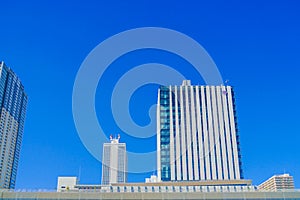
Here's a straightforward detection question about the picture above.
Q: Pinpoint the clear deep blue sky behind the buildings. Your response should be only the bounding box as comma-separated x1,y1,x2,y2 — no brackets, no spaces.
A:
0,0,300,189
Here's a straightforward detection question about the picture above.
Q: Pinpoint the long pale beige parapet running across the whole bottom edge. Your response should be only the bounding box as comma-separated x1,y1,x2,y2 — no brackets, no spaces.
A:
0,186,300,200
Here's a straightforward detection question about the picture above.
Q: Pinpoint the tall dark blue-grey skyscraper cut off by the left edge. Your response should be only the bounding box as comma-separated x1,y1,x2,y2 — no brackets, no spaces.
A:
0,62,27,188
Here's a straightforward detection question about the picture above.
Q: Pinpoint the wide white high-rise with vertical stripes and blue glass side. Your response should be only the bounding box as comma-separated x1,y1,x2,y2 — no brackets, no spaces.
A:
157,80,243,181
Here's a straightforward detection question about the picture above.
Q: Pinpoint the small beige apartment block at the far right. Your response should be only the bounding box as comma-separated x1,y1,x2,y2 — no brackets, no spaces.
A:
258,174,295,191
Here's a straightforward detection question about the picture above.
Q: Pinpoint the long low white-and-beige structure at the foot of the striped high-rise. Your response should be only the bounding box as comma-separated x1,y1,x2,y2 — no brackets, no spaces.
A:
57,177,256,193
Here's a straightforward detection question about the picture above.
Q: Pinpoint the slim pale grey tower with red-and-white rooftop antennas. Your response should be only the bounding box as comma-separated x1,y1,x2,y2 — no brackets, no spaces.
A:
102,136,127,185
